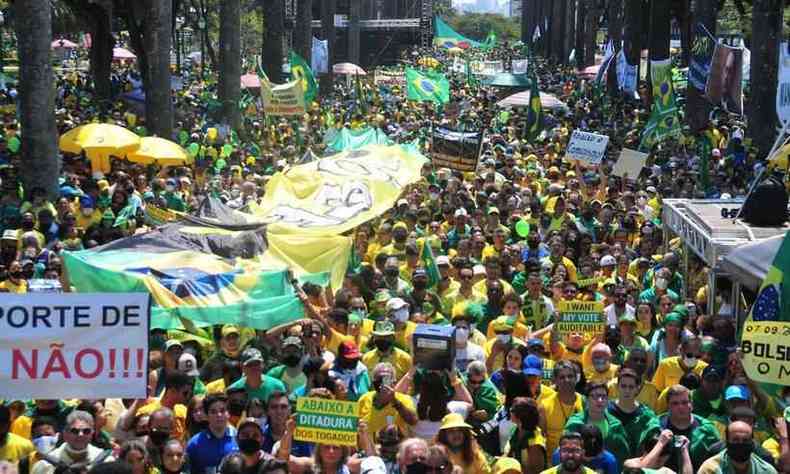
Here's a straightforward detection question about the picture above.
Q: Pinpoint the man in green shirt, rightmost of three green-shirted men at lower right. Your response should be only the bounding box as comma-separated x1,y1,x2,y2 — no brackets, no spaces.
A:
658,385,720,471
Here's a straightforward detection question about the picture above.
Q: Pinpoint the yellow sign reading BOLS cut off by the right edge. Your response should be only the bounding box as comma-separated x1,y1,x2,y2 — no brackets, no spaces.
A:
741,321,790,385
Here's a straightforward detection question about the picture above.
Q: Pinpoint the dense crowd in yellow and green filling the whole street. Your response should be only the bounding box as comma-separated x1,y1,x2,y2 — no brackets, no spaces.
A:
0,36,790,474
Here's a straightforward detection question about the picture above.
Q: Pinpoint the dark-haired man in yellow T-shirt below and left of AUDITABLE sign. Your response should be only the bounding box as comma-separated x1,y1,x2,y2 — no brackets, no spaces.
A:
538,360,584,453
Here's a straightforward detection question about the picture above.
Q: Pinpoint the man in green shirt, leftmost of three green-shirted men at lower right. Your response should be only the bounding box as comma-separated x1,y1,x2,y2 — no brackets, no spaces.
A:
560,383,630,468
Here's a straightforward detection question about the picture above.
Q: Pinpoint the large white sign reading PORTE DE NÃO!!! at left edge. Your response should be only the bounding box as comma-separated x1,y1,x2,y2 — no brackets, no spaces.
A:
0,293,150,400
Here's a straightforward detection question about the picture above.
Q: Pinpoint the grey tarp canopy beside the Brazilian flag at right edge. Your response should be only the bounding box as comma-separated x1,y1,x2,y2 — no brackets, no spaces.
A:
721,235,785,291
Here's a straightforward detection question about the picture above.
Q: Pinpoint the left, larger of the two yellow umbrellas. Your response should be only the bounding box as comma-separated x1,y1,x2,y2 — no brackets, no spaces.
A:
59,123,140,173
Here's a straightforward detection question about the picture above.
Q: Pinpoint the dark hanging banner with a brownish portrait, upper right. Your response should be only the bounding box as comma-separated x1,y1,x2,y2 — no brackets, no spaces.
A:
705,43,743,114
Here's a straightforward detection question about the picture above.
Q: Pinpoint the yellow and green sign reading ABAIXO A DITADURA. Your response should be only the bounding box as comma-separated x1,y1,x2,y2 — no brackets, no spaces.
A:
294,397,359,446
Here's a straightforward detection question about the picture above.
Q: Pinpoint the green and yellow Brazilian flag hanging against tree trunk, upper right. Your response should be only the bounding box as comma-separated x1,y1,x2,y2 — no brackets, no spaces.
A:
639,59,681,149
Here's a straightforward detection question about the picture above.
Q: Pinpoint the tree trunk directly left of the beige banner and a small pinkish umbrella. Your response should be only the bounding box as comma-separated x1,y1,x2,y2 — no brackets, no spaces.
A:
218,0,241,130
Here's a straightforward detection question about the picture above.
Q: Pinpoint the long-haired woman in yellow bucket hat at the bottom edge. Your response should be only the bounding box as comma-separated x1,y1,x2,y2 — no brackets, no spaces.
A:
436,413,491,474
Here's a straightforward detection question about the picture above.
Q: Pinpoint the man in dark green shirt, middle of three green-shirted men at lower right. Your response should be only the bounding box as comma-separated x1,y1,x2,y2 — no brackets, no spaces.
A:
607,367,659,457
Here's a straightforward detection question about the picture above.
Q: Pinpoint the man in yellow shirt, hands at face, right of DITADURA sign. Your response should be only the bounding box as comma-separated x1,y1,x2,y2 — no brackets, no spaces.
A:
359,362,417,441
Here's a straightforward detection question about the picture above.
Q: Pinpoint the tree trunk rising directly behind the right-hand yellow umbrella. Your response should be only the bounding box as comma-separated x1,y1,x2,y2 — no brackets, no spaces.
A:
143,0,173,140
